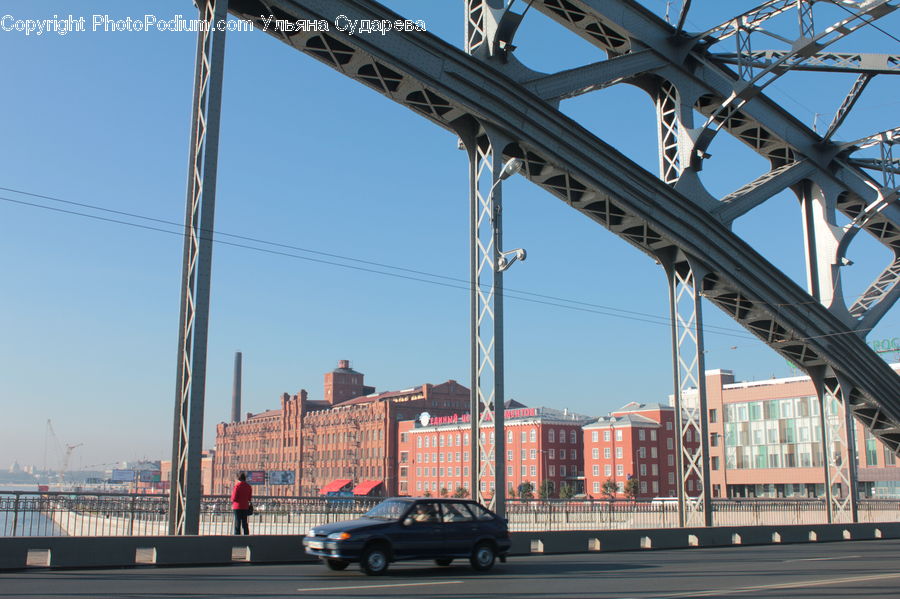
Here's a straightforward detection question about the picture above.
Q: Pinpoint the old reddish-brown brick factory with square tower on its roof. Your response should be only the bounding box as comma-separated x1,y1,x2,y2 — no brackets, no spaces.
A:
213,360,469,496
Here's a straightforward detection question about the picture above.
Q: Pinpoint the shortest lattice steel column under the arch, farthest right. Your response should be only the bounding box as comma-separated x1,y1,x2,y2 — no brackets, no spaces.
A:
811,369,859,524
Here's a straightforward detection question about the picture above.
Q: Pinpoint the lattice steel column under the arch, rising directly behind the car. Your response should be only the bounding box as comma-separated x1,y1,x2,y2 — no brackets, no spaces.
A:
461,124,510,516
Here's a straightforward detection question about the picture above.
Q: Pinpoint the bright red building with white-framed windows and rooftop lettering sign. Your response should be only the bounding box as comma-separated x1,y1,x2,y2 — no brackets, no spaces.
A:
398,402,589,497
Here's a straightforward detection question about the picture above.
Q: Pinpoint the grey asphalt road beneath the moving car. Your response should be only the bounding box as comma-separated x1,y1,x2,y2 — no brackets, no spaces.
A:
0,540,900,599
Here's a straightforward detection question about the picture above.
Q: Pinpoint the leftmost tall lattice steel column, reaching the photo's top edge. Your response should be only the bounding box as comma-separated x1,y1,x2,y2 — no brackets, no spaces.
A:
169,0,228,535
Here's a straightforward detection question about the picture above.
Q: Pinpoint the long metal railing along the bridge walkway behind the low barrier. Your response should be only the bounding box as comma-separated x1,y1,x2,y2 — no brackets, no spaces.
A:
0,491,900,537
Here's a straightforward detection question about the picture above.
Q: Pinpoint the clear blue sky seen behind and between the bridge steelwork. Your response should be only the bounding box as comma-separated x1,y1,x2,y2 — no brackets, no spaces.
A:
0,0,900,468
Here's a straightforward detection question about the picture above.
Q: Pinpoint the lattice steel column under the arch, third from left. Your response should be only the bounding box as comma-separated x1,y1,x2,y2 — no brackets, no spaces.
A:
660,257,712,527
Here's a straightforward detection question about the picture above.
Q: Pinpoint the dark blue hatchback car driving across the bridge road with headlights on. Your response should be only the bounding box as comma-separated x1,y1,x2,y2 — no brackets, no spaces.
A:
303,497,511,576
